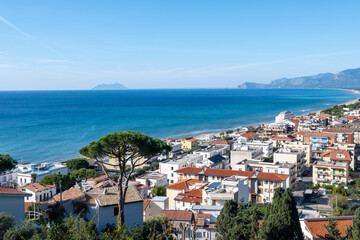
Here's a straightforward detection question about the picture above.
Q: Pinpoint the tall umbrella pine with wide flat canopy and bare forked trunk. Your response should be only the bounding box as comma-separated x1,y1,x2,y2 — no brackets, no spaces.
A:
80,131,171,229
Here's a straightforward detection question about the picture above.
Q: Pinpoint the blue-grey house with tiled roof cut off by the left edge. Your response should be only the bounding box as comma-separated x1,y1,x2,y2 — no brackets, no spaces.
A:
0,187,31,222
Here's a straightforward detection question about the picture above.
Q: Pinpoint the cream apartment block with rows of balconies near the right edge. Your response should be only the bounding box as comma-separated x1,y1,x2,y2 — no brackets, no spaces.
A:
313,161,350,186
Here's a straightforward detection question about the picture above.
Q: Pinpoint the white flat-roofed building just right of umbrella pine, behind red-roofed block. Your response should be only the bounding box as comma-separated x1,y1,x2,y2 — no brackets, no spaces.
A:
159,154,203,184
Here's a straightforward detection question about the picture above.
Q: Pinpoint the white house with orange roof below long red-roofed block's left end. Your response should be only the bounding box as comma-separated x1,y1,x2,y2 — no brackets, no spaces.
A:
166,179,209,209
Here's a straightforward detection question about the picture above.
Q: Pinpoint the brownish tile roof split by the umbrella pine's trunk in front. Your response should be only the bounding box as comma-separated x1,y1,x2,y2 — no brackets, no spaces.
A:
96,184,143,206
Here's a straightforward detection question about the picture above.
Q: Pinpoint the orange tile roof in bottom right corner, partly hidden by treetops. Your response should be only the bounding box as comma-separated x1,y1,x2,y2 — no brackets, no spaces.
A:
304,216,354,238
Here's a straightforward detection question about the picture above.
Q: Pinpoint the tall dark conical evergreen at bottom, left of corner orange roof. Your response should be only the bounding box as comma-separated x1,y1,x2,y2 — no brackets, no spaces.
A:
259,188,304,240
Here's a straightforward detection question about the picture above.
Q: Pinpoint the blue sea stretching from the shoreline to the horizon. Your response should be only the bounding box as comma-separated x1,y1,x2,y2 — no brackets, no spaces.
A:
0,89,359,162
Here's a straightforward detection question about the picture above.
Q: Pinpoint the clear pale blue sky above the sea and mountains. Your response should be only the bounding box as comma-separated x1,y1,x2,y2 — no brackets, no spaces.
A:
0,0,360,90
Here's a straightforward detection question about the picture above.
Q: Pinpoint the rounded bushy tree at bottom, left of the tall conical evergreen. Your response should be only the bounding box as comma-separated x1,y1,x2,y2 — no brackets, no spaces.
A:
215,200,260,240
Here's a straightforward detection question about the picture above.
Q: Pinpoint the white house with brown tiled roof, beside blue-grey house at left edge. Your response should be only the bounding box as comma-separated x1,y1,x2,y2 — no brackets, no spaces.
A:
18,183,56,202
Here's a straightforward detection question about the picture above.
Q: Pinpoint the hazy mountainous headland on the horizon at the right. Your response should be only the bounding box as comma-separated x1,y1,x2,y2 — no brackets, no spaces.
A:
238,68,360,89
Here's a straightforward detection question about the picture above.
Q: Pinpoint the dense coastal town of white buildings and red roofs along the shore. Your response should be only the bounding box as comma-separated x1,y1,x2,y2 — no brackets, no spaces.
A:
0,100,360,240
